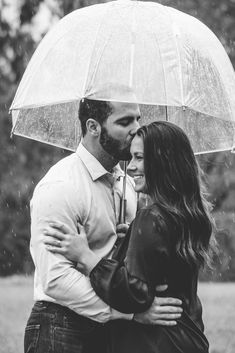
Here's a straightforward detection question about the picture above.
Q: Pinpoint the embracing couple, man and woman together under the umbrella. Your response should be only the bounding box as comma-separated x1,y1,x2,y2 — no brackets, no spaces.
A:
25,99,213,353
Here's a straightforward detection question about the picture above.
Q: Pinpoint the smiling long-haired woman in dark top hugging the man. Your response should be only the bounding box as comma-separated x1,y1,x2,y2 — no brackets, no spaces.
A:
45,121,212,353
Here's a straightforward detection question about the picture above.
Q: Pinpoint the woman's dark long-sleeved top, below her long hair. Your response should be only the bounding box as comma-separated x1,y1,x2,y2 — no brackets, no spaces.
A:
90,205,208,353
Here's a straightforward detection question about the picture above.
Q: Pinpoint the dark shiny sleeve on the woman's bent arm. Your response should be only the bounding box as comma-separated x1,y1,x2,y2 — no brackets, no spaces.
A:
90,209,169,313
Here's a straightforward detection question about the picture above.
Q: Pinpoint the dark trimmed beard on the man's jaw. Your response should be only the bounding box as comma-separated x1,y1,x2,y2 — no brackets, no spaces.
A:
100,126,131,161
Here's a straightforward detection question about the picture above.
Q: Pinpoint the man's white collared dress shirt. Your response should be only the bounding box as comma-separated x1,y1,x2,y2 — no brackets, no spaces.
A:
30,143,137,322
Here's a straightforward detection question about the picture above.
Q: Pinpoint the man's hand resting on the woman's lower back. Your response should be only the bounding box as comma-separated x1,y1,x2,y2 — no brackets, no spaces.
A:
133,297,183,326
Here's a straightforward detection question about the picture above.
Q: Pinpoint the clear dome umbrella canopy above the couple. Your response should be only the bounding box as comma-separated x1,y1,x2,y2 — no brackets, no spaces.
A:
10,0,235,153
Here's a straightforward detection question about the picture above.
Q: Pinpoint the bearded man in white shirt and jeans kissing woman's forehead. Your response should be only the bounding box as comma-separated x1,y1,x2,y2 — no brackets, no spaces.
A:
25,99,181,353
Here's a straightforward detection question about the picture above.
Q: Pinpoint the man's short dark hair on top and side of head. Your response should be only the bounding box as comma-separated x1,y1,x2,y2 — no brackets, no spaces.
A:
78,98,112,136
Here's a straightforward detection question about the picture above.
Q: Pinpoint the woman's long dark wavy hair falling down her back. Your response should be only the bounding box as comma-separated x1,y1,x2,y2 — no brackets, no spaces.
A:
137,121,213,268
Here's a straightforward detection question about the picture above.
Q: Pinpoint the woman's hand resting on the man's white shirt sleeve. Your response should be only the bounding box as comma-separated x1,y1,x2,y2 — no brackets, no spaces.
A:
43,221,100,274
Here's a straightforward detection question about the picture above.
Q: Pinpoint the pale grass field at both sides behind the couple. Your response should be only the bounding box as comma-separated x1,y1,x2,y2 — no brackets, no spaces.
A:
0,276,235,353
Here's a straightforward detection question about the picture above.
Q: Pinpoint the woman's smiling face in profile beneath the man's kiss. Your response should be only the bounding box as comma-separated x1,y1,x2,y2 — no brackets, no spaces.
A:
127,135,146,192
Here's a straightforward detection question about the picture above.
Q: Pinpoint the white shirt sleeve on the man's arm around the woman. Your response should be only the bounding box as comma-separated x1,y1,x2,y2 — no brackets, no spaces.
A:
30,181,133,322
